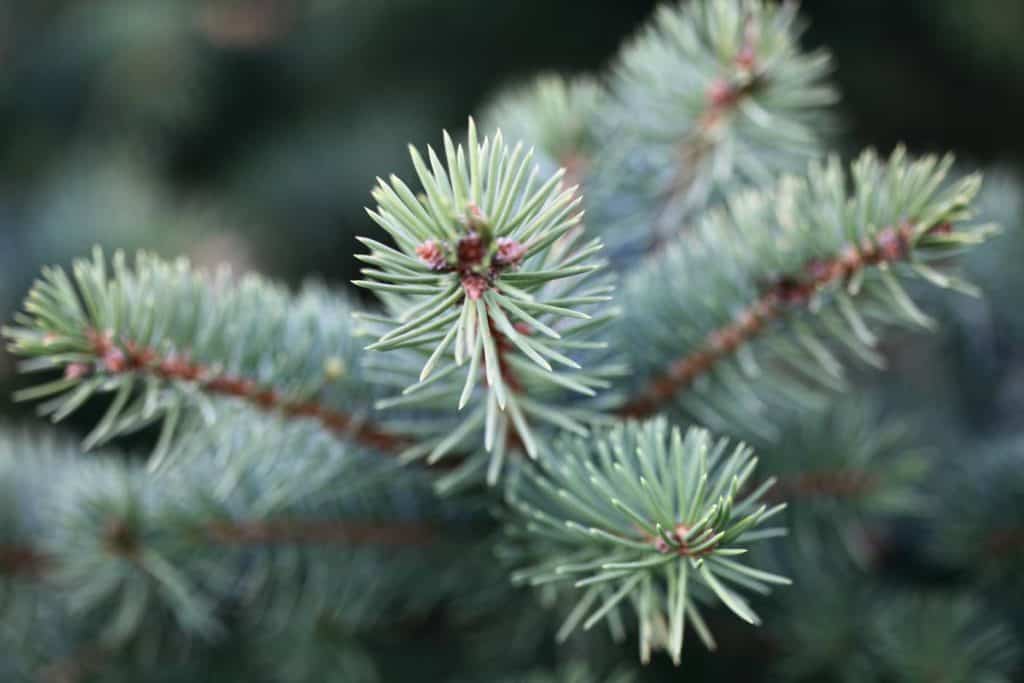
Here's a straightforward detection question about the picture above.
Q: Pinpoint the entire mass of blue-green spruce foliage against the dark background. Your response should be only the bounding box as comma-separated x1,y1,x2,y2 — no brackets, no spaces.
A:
0,0,1024,683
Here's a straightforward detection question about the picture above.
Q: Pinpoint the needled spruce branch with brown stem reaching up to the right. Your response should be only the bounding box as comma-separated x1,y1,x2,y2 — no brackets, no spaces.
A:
616,148,992,439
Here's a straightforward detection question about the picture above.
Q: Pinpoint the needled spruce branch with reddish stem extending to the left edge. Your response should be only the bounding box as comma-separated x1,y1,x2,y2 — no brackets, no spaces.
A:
3,249,407,462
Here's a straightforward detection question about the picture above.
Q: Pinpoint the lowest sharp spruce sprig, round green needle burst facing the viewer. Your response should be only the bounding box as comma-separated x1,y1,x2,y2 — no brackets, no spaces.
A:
507,419,790,665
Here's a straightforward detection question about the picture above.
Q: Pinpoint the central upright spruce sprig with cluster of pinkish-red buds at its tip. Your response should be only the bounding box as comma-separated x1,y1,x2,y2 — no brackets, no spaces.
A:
356,120,613,478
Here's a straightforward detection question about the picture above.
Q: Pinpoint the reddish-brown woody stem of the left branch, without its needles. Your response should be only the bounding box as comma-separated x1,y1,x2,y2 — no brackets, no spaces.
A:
78,331,408,452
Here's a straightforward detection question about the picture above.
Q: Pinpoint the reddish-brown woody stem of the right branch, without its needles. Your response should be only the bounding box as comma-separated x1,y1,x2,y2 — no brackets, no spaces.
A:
618,223,951,418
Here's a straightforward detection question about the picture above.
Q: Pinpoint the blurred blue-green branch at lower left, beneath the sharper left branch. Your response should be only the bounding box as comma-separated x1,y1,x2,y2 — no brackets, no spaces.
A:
0,419,459,649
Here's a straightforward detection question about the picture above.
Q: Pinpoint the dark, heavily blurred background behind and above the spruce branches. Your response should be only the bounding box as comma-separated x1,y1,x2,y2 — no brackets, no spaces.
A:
0,0,1024,673
